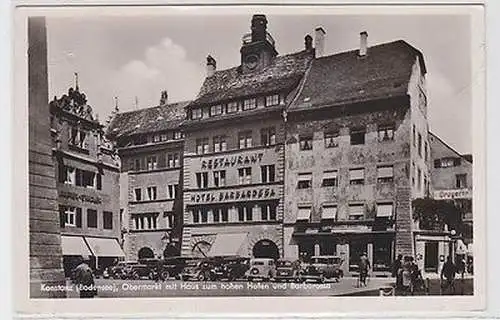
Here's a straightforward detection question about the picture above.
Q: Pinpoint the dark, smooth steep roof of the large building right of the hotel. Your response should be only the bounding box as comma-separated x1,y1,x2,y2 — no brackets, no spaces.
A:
289,40,425,111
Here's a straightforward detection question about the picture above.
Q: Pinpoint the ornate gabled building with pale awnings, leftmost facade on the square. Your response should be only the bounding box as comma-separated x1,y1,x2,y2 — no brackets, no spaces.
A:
50,84,124,276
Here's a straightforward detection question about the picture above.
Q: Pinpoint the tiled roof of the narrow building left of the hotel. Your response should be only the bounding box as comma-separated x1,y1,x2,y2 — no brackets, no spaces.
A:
107,101,190,137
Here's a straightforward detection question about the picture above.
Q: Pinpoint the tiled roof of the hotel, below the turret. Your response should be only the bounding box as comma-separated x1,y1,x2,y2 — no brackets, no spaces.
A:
193,51,313,105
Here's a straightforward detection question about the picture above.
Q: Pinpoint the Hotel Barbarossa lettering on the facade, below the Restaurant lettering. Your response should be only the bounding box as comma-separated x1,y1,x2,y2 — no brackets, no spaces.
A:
191,187,278,203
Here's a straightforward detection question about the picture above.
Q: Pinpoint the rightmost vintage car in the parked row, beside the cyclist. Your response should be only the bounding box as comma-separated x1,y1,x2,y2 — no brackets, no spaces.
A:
301,256,344,283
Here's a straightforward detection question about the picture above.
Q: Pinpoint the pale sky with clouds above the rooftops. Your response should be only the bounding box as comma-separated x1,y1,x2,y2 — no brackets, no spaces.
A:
47,12,472,153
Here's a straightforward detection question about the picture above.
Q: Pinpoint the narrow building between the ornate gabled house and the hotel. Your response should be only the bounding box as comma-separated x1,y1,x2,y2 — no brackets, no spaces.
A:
107,91,188,260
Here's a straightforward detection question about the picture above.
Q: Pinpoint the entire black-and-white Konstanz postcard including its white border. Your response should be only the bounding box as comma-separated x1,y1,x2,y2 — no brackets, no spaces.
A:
14,1,486,314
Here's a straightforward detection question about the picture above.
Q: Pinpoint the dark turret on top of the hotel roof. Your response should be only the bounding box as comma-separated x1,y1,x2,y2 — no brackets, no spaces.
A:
240,14,278,73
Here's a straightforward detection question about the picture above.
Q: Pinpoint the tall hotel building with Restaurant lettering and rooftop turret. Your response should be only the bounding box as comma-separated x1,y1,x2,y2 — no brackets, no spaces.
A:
182,15,313,258
